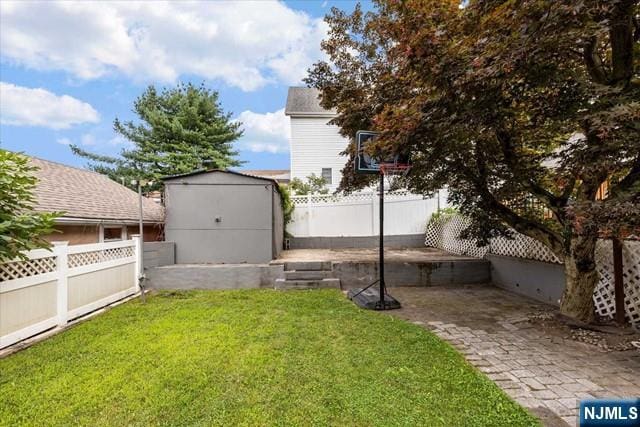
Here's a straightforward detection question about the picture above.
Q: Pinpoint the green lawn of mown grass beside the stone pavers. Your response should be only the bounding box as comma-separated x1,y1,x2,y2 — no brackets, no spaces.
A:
0,290,538,426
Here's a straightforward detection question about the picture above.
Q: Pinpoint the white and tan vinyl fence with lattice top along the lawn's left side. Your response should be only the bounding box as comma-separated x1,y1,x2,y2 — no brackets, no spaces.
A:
0,236,142,348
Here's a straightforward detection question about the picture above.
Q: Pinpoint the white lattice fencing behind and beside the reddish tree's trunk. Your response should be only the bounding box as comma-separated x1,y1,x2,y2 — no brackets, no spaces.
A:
425,215,640,329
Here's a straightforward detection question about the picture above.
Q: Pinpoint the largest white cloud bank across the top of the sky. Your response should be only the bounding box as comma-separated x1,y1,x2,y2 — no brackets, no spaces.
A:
0,1,327,91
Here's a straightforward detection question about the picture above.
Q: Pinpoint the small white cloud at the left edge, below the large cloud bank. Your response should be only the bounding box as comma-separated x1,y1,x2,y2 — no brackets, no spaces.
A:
0,82,100,129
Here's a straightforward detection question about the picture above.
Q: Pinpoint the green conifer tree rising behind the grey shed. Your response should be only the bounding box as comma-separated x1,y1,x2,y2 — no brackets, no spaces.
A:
71,83,242,190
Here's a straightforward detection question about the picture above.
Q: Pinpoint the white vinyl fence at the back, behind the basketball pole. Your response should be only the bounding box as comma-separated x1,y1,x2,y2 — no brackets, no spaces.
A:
287,191,447,237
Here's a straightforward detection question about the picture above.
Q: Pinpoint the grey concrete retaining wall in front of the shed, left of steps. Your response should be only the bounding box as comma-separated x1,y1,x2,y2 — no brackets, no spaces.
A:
146,264,284,289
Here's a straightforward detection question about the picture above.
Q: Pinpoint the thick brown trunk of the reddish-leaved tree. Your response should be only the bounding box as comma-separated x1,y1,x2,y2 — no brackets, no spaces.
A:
560,236,598,323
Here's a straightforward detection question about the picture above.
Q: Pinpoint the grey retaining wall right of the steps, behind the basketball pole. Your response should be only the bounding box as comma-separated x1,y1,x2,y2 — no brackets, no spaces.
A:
333,259,491,289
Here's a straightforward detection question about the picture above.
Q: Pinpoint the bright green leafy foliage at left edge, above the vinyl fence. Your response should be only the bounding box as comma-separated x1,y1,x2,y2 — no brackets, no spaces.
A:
0,150,59,262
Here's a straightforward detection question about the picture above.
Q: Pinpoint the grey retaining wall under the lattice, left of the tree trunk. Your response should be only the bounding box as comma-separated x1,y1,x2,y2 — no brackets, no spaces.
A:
486,254,565,305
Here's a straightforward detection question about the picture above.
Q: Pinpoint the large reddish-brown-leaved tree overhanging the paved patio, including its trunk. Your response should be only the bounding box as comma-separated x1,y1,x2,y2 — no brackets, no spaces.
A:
307,0,640,321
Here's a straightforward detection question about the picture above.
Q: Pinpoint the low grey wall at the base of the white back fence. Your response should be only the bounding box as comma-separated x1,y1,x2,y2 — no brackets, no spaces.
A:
289,234,424,249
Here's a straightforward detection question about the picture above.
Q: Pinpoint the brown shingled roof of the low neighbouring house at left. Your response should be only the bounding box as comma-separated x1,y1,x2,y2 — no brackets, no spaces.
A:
30,157,164,223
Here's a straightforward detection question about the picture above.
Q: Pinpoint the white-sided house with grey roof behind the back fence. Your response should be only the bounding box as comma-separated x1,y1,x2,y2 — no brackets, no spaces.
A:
285,87,349,191
